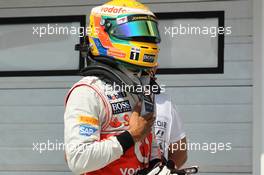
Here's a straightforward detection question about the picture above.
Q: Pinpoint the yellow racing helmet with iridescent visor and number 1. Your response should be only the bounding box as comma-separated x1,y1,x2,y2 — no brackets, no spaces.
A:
88,0,160,68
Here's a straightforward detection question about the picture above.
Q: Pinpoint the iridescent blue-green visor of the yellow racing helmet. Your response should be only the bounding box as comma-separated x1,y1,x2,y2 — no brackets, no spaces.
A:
110,20,160,43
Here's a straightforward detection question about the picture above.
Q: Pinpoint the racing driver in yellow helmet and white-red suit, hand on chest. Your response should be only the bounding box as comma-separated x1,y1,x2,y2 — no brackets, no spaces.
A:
64,0,163,175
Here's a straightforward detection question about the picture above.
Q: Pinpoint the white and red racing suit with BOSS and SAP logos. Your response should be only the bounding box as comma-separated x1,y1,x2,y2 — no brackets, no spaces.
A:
64,73,160,175
